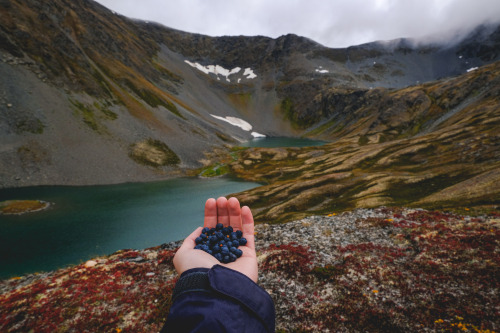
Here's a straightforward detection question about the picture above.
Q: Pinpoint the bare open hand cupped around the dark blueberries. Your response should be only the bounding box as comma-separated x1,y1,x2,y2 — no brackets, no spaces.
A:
174,197,258,282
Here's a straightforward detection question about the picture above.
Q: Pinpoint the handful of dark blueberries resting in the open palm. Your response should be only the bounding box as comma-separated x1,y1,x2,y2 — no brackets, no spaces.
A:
194,223,247,264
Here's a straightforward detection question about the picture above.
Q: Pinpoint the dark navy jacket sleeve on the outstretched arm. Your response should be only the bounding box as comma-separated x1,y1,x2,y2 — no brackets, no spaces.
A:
161,265,275,333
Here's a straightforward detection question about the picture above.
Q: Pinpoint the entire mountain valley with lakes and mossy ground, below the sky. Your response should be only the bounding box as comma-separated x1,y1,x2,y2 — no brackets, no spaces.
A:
0,0,500,333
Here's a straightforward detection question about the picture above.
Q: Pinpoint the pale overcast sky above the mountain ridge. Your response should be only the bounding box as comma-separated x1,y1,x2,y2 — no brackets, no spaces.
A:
97,0,500,47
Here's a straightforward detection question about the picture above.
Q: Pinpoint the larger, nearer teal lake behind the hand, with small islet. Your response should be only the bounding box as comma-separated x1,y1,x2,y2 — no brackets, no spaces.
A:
0,178,259,279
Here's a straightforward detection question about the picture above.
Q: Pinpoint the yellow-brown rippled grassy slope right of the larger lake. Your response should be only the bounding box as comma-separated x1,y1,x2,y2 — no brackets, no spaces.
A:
231,63,500,223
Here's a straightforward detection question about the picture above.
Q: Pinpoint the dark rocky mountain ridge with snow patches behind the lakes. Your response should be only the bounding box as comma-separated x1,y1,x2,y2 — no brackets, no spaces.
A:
0,0,500,187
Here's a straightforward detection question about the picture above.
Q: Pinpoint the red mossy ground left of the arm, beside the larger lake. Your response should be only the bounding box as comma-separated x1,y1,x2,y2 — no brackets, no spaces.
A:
0,251,177,333
